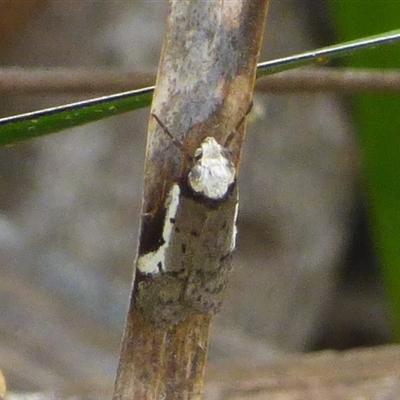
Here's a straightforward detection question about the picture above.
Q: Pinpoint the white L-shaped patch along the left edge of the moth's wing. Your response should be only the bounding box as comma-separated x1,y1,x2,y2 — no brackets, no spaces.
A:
137,184,181,275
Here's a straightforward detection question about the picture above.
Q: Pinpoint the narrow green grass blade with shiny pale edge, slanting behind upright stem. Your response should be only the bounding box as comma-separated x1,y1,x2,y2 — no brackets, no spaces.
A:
0,29,400,146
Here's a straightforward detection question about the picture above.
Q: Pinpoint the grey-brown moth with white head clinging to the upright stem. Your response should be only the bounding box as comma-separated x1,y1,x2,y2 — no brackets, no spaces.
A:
135,104,252,327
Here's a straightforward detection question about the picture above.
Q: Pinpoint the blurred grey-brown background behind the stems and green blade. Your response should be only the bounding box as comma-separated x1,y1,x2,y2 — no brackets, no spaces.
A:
0,0,393,391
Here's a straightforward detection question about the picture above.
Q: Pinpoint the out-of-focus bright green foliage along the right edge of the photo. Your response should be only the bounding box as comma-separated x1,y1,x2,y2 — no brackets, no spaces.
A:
329,0,400,342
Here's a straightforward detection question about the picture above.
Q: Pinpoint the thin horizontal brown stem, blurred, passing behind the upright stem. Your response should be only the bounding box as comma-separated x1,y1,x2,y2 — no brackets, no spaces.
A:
0,67,400,95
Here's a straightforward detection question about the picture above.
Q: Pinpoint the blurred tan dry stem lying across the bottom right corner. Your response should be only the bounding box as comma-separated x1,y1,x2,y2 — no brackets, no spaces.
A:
205,345,400,400
